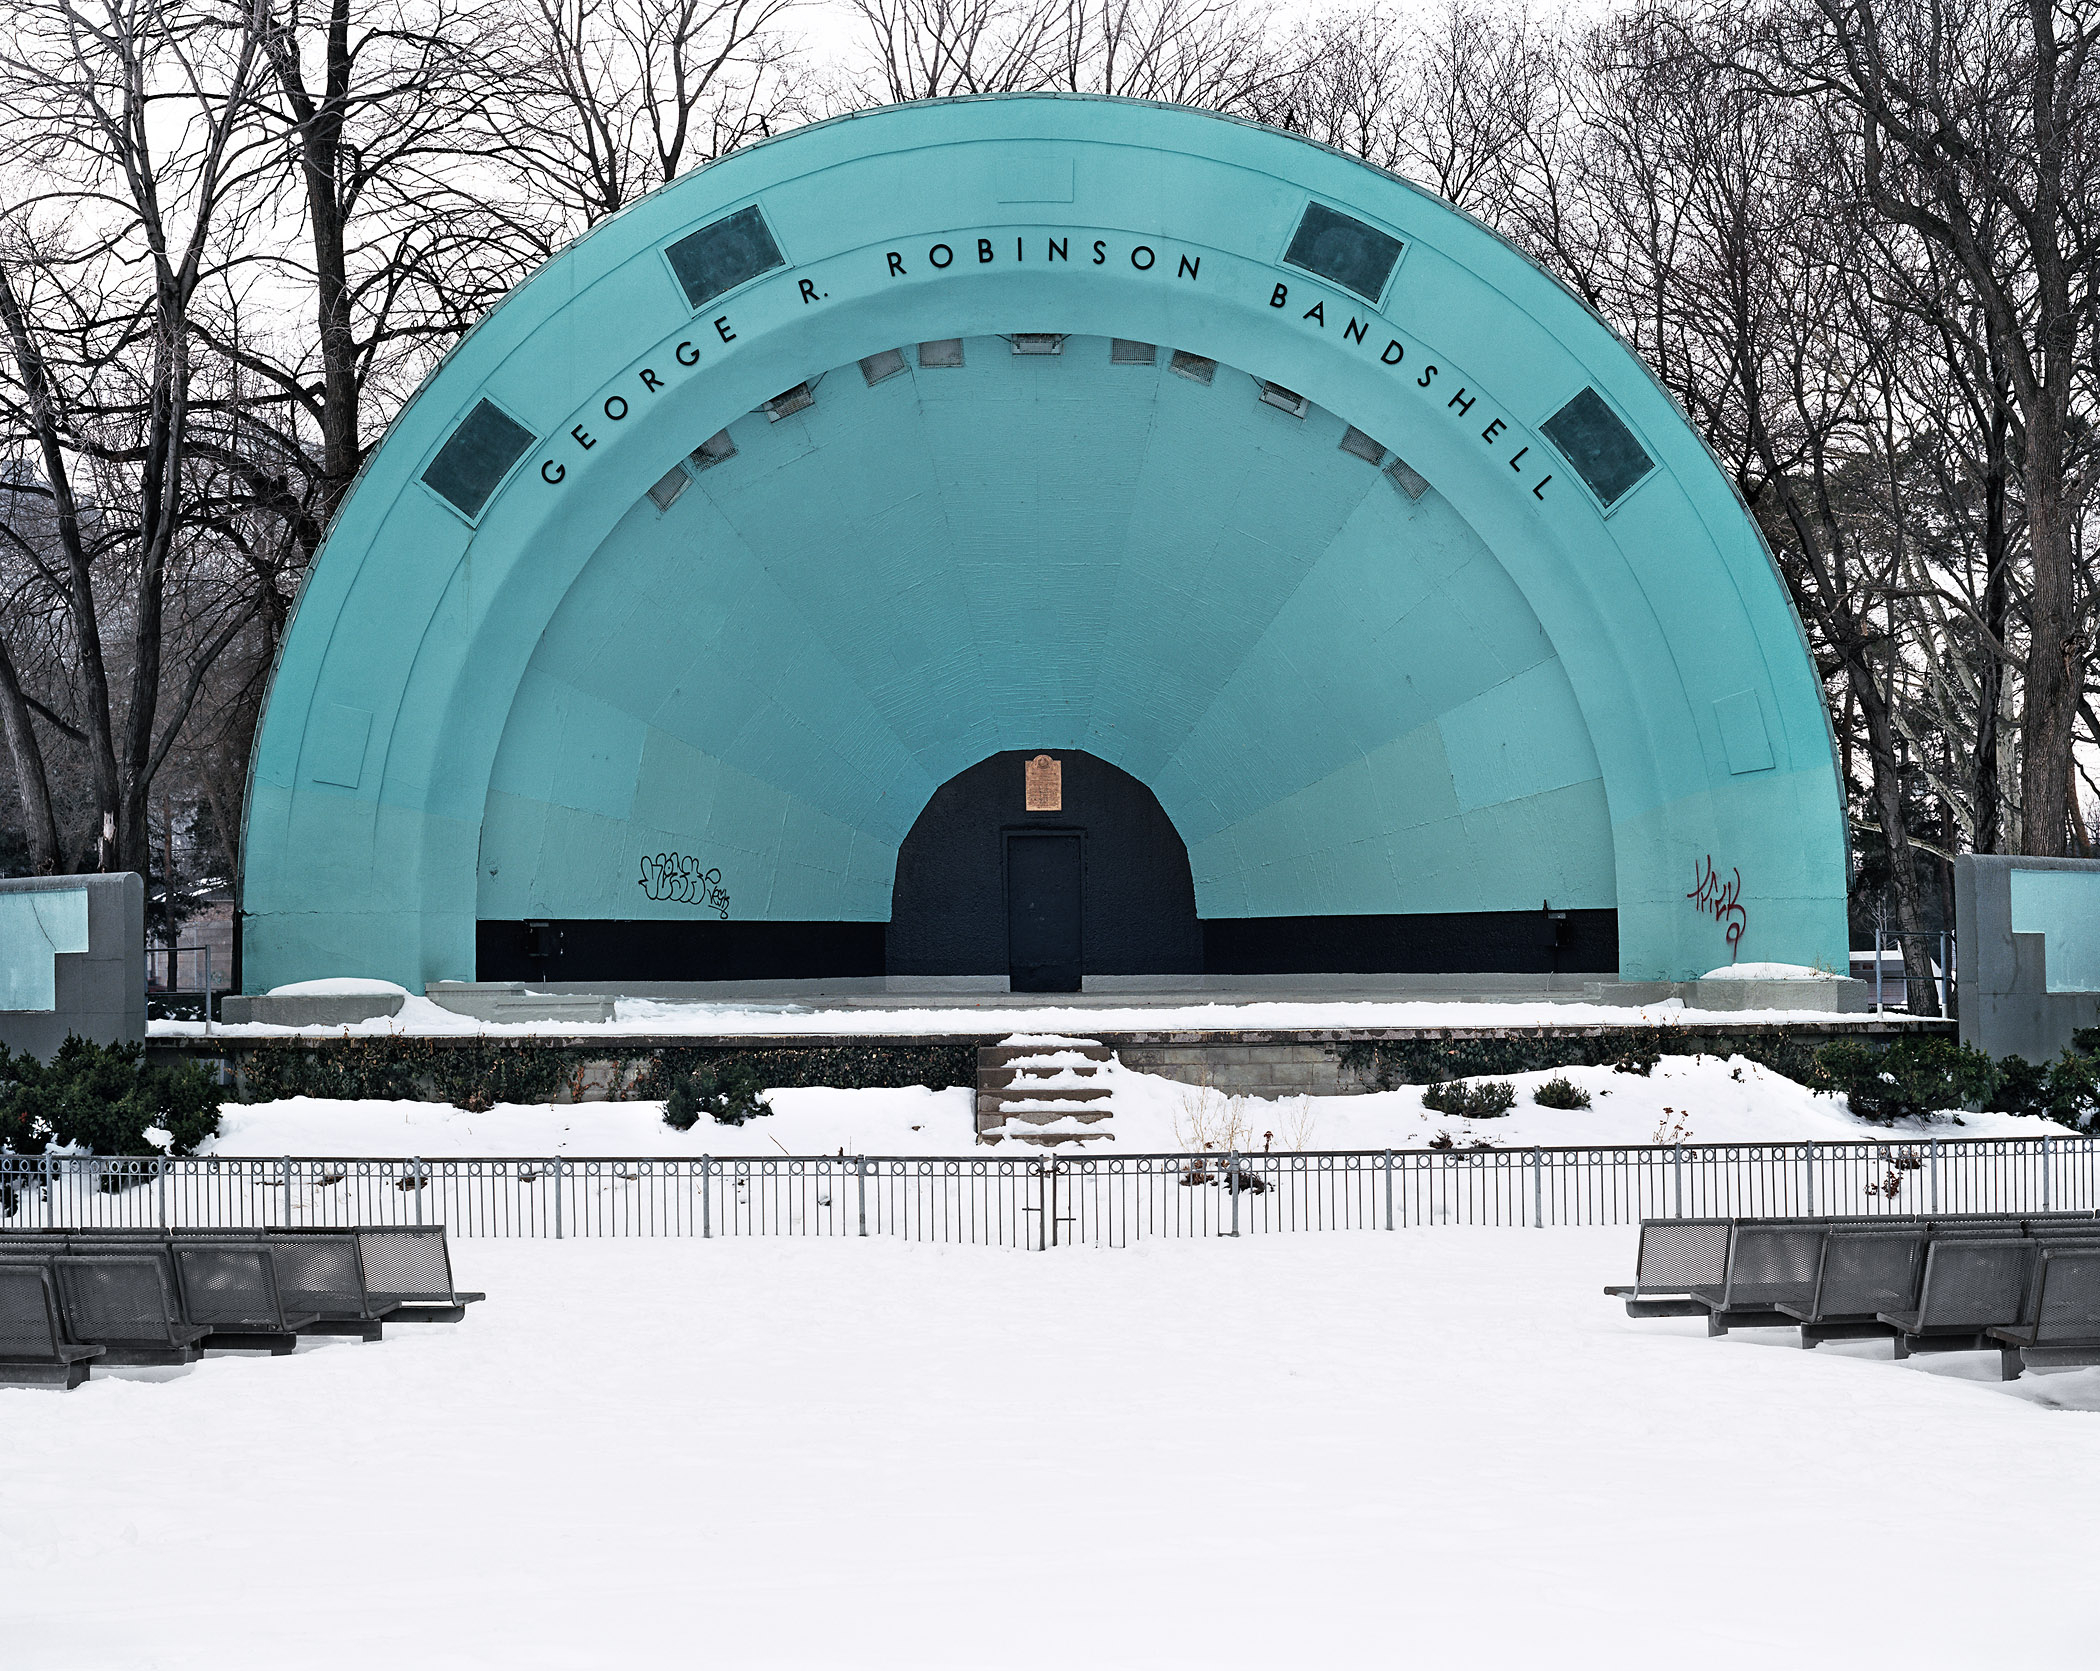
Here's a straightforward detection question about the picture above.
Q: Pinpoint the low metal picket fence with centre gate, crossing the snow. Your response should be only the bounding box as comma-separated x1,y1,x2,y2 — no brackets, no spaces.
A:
0,1134,2100,1249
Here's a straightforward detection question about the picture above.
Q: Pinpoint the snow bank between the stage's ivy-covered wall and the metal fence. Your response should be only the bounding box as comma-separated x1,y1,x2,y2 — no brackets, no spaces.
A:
204,1056,2064,1159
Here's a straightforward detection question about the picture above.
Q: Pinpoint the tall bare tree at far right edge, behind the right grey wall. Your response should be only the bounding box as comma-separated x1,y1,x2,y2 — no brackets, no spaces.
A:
1741,0,2100,856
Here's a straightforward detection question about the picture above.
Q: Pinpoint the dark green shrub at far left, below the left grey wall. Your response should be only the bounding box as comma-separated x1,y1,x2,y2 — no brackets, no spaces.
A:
0,1039,225,1155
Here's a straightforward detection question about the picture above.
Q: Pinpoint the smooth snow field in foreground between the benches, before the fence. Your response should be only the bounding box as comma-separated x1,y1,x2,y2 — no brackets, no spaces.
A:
0,1230,2100,1671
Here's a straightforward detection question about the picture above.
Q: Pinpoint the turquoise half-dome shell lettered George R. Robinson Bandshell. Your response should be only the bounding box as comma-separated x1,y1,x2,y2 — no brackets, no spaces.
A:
244,97,1846,989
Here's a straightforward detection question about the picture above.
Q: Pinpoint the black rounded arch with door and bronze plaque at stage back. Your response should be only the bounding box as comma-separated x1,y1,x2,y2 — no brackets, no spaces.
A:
888,749,1203,991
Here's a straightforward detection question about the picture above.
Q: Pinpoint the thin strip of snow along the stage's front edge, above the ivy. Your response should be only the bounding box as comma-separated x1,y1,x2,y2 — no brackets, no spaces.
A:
159,980,1859,1039
